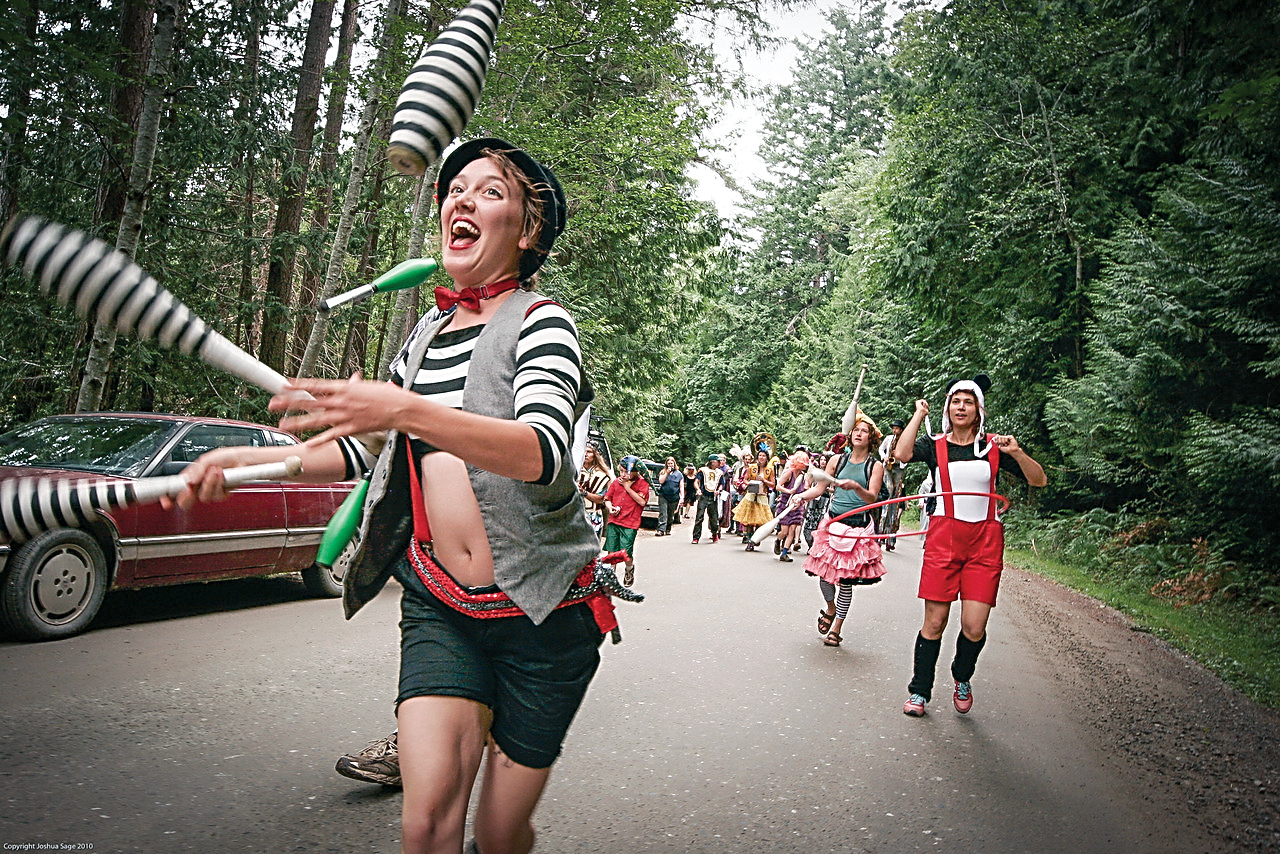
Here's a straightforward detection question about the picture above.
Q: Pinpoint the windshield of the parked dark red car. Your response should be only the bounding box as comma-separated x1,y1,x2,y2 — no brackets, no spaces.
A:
0,417,178,478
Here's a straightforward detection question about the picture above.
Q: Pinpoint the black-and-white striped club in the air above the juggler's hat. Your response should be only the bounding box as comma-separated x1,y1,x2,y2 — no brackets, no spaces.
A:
387,0,506,175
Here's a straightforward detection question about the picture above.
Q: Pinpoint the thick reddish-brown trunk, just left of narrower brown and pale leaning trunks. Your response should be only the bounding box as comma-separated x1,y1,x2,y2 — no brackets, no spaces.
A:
259,0,334,370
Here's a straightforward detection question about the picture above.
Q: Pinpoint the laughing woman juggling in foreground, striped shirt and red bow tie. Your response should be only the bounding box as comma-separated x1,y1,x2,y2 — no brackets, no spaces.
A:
168,138,616,853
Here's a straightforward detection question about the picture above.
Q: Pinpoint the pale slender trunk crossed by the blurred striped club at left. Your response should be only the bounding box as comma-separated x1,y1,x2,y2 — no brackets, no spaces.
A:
76,0,187,412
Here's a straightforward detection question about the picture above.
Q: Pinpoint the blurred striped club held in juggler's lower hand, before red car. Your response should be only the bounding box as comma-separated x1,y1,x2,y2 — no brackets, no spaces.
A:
0,457,302,543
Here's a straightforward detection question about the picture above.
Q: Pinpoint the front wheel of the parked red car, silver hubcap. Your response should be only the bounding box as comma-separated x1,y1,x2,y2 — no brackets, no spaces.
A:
0,528,108,640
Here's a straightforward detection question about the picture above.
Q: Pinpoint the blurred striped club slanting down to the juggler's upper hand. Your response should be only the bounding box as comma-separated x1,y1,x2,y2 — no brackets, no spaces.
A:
0,216,294,394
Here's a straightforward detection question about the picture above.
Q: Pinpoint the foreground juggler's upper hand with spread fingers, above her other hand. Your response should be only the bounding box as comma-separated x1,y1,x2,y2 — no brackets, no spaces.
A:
270,373,422,447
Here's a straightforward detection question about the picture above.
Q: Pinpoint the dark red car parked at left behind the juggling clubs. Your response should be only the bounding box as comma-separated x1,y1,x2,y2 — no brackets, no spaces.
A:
0,412,355,640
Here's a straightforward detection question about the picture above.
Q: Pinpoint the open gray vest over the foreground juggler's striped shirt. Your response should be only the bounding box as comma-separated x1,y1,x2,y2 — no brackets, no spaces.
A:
335,291,600,624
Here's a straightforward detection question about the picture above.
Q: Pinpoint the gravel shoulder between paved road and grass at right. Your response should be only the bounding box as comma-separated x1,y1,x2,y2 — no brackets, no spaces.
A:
1001,567,1280,851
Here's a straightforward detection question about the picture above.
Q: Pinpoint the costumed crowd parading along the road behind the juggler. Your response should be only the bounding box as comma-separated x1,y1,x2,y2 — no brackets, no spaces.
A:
580,374,1046,717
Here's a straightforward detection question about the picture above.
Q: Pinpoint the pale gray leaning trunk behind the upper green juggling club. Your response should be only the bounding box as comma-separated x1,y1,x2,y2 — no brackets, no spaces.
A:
298,0,403,376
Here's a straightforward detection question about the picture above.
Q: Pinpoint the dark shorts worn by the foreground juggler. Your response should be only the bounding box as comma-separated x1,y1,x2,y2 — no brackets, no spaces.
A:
394,558,604,768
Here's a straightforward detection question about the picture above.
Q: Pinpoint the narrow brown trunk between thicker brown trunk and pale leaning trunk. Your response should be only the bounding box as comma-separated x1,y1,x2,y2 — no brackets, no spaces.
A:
289,0,360,370
